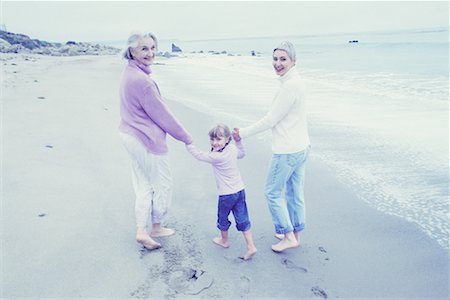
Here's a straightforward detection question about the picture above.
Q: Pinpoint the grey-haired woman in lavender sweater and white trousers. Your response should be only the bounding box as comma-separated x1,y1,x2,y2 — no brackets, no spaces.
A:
119,33,192,250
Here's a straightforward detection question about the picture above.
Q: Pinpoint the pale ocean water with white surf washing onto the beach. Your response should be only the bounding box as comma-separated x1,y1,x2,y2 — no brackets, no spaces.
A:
146,28,450,249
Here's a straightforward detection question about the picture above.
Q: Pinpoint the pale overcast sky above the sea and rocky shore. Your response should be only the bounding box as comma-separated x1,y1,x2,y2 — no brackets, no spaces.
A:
0,0,449,42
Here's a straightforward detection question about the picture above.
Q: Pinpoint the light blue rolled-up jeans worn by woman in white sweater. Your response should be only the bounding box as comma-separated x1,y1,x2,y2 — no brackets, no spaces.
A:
265,146,310,234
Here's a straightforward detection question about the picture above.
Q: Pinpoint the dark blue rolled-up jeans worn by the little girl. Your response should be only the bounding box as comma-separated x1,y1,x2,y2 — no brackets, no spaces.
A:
217,190,251,231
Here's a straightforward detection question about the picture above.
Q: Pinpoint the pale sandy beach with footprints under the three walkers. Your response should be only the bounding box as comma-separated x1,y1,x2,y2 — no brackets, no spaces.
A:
0,54,450,299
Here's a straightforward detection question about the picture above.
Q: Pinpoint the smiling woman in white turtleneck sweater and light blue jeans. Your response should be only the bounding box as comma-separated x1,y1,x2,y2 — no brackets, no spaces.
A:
233,42,310,252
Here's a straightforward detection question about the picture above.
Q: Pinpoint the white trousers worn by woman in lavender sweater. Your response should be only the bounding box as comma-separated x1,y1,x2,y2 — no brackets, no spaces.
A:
119,132,173,229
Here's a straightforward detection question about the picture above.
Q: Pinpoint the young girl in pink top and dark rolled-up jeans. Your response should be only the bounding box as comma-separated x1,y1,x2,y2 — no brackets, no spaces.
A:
186,124,256,260
